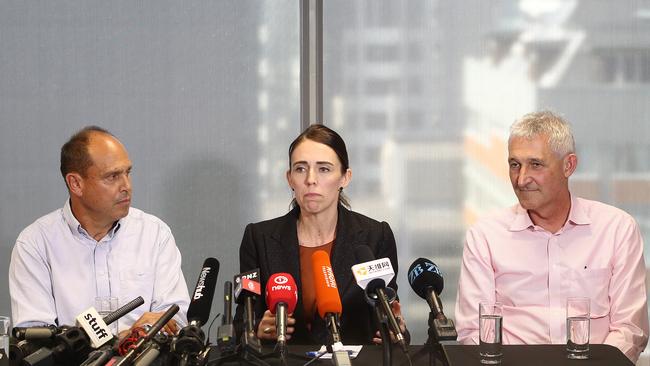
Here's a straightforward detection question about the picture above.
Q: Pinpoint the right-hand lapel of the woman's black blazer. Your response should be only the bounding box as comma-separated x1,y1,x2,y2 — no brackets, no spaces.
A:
331,206,365,296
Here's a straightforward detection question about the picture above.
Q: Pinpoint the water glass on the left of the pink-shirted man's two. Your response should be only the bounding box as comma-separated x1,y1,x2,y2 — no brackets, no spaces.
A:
478,302,503,365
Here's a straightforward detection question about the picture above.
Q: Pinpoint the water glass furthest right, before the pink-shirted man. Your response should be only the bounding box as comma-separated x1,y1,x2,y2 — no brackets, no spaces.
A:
566,297,590,360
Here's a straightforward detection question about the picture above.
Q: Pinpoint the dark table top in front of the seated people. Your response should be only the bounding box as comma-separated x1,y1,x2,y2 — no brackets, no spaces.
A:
206,344,634,366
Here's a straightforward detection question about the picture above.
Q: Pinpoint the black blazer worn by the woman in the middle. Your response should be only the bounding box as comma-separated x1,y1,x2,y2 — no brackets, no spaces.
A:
234,205,398,344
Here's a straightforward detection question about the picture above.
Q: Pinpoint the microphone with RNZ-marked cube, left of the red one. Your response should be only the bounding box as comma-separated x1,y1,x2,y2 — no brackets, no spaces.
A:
233,268,262,354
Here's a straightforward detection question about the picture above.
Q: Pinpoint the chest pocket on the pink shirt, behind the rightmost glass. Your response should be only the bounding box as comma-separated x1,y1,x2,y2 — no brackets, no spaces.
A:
569,268,612,319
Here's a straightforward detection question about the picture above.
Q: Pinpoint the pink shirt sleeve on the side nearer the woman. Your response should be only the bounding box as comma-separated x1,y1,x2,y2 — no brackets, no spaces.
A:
455,223,496,344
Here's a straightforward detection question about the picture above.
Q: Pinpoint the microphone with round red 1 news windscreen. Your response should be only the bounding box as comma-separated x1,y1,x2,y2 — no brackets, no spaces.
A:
266,273,298,350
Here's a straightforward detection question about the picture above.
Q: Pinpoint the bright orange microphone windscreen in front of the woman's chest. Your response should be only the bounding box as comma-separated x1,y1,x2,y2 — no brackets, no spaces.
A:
311,250,343,318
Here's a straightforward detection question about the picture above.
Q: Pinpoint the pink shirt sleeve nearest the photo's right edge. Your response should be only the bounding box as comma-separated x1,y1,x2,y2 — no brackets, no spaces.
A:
604,217,648,362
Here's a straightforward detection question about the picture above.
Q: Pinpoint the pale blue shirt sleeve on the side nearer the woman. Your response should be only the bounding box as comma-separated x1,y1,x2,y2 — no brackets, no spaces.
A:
151,227,190,326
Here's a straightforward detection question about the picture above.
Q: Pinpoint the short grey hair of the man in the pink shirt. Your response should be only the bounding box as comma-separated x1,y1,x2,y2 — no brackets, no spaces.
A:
508,111,576,157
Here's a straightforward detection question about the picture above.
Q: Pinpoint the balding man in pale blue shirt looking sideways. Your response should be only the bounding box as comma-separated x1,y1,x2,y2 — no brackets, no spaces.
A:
9,126,189,334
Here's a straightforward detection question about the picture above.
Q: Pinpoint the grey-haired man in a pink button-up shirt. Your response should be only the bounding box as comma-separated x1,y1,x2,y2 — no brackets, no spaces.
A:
456,112,648,362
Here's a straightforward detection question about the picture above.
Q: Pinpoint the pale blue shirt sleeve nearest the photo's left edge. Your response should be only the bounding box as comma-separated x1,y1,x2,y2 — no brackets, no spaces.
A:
9,233,57,327
